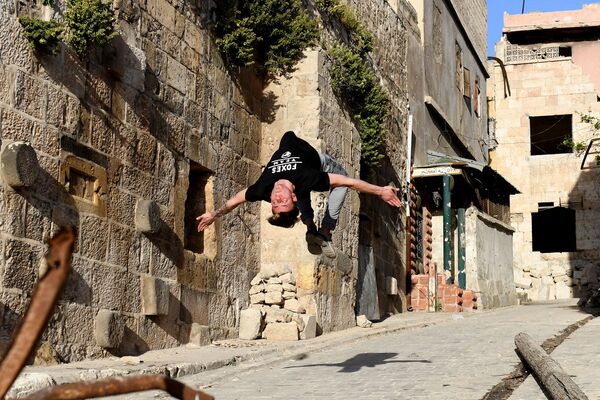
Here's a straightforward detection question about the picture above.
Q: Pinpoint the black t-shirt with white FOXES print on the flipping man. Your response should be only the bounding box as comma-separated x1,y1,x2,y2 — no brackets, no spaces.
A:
246,131,329,204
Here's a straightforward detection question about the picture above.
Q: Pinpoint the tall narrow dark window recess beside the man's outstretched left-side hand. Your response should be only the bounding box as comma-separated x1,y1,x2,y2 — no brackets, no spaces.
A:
183,161,211,253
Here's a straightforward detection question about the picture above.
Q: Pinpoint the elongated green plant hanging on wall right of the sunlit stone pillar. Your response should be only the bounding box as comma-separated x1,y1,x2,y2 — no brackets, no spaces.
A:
328,44,390,168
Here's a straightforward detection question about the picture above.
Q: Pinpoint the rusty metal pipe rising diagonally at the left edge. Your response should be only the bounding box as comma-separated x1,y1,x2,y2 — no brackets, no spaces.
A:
0,228,75,399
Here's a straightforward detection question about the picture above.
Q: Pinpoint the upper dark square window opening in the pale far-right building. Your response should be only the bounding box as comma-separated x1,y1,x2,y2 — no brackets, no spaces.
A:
529,114,573,156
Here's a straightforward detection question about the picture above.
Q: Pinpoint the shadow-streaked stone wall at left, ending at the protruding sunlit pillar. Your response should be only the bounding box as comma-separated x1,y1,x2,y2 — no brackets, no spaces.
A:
0,0,262,361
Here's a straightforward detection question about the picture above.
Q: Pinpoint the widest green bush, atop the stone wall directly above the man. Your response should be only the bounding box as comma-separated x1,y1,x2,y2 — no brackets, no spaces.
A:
214,0,319,76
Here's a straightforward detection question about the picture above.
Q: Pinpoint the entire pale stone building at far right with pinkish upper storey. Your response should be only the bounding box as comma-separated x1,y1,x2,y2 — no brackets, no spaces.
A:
488,3,600,300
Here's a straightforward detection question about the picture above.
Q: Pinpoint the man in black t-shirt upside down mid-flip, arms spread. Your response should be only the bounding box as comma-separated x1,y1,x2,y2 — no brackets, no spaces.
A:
196,131,401,258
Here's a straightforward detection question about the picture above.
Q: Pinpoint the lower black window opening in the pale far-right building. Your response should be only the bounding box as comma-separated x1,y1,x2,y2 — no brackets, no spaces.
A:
531,207,577,253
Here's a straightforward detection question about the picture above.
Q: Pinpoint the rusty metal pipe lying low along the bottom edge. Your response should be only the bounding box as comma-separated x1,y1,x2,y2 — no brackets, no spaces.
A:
26,375,214,400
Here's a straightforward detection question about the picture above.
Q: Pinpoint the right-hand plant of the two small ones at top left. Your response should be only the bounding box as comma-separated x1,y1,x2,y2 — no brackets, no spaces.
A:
65,0,117,57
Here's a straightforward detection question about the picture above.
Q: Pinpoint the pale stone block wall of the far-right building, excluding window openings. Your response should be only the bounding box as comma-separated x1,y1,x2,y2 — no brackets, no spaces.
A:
489,41,600,301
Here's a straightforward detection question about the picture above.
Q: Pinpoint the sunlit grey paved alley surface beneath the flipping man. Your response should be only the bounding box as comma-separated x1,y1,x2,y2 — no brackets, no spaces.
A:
111,301,600,400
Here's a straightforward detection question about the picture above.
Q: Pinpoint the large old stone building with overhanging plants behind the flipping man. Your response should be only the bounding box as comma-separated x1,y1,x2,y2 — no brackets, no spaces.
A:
0,0,416,361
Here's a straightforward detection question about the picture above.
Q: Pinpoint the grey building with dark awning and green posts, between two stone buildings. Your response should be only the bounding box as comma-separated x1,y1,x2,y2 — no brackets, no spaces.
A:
398,0,516,311
